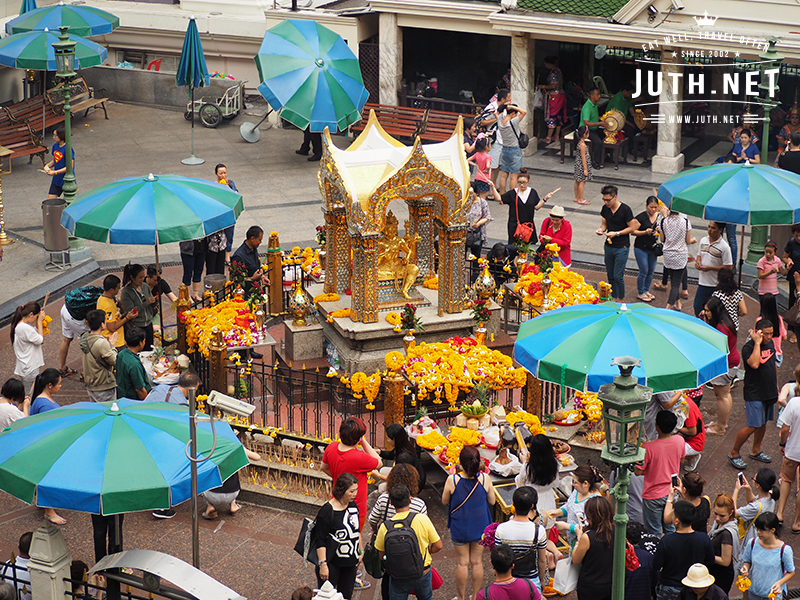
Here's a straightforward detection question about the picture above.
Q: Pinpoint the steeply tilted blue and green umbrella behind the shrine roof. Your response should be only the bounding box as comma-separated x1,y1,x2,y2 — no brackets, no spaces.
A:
255,19,369,132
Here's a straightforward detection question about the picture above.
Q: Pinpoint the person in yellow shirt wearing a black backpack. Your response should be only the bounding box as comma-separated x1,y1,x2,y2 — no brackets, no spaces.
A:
375,483,443,600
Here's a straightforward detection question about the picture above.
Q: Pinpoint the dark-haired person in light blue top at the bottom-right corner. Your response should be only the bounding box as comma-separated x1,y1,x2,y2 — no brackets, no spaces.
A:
741,512,794,600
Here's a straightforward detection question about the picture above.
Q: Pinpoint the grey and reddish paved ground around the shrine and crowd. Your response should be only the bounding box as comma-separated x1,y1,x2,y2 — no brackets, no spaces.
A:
0,98,800,599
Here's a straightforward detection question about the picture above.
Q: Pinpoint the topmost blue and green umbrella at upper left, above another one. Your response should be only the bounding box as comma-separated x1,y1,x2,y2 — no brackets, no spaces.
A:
6,0,119,37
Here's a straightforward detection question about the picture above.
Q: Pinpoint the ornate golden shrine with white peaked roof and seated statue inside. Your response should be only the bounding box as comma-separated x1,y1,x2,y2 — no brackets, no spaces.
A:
318,111,470,323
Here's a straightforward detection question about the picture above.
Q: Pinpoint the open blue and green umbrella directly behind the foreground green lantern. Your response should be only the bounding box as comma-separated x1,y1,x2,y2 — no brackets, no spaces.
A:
514,302,728,392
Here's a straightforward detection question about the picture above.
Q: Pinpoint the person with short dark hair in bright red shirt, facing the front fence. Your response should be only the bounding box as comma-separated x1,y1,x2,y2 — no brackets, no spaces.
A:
322,417,381,531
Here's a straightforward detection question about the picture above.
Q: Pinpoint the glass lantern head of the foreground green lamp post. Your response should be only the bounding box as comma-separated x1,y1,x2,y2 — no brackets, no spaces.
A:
598,356,653,466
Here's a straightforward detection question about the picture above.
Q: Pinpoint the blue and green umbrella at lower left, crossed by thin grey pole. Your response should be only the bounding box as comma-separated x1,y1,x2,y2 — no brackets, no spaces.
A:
0,399,248,515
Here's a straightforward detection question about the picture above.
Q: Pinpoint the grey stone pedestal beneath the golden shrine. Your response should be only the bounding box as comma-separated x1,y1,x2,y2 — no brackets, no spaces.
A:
312,285,500,374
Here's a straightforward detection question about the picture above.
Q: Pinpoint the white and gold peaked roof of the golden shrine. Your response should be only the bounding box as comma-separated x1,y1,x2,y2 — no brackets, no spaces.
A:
326,111,470,230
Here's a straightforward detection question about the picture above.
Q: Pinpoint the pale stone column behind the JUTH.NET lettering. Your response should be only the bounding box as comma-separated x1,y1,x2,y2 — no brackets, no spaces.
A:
650,49,684,174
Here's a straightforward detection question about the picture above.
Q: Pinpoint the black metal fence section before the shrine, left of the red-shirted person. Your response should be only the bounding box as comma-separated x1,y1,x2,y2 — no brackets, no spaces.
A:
227,362,384,445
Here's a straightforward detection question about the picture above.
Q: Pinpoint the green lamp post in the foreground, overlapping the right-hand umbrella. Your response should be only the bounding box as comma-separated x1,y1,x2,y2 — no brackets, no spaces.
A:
597,356,653,600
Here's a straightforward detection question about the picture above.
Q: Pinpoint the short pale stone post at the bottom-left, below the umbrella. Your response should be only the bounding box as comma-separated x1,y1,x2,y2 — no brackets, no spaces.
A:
28,520,72,600
